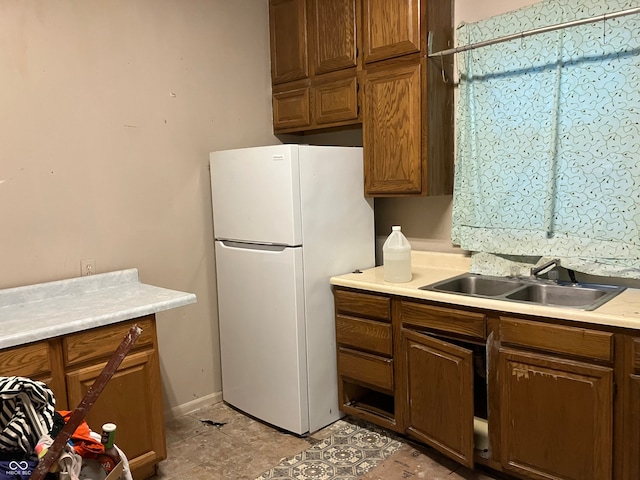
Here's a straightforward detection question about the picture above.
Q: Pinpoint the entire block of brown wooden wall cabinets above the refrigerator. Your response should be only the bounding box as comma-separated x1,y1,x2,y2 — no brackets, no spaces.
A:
270,0,454,197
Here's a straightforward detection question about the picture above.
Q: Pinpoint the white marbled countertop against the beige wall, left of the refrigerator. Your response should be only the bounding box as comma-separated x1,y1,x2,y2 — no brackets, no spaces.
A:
0,268,196,348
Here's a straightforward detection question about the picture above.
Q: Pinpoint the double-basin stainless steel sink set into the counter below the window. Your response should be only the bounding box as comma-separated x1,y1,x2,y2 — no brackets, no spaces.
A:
420,273,625,310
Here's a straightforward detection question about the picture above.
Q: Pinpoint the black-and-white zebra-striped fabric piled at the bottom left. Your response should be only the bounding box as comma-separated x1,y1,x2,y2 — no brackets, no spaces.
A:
0,377,55,454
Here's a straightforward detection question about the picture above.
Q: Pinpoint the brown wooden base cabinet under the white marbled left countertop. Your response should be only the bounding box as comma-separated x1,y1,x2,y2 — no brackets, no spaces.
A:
0,315,167,480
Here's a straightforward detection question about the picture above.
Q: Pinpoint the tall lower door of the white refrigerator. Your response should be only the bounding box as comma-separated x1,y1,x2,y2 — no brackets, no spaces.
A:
215,241,309,434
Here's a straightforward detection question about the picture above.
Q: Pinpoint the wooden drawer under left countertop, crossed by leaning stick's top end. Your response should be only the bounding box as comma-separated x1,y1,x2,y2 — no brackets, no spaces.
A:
63,316,155,366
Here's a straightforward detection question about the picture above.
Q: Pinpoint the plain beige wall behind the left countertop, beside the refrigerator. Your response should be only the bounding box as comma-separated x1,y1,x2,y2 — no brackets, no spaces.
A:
0,0,277,409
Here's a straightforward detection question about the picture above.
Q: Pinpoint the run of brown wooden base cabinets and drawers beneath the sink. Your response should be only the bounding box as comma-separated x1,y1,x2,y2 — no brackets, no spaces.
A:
334,287,640,480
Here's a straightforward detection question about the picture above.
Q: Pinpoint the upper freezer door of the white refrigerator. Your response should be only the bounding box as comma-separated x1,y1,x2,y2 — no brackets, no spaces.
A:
210,145,302,245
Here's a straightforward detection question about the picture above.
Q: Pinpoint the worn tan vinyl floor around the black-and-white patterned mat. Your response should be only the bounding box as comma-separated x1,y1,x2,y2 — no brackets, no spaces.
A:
152,402,499,480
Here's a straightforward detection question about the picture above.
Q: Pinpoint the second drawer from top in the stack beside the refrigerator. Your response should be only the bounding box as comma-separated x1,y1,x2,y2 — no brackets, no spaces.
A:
336,315,392,356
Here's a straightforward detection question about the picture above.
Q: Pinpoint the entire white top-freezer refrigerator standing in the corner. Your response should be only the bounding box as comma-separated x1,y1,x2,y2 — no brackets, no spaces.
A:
210,145,375,435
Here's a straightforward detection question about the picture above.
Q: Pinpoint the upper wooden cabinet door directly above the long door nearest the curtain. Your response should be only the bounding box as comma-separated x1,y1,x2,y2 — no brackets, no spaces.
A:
363,0,422,63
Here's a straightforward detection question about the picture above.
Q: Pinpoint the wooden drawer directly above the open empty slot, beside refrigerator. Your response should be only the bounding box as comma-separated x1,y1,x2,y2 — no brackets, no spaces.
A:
338,348,393,391
